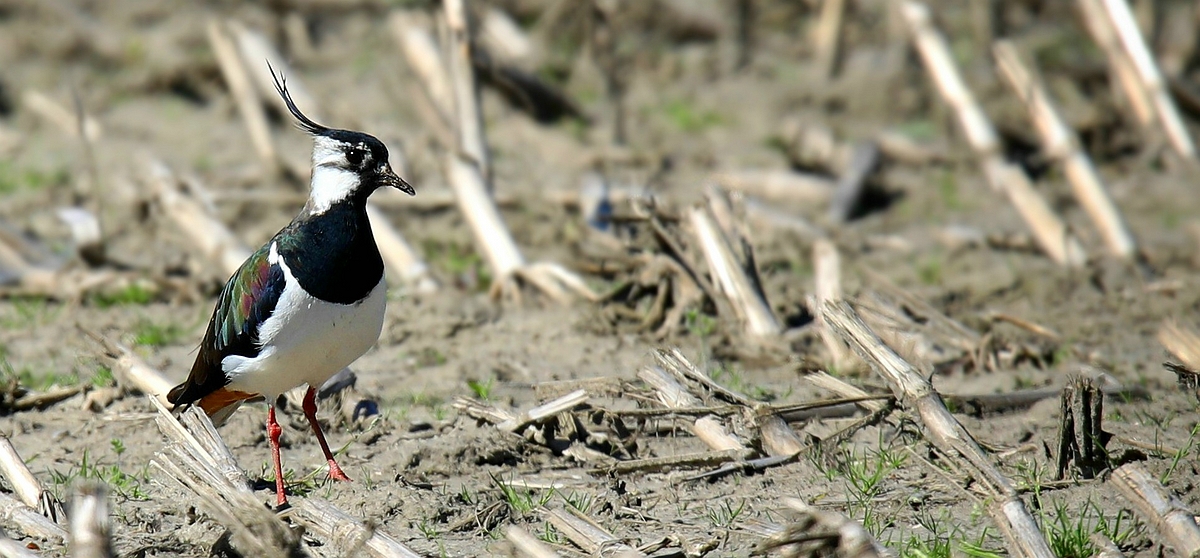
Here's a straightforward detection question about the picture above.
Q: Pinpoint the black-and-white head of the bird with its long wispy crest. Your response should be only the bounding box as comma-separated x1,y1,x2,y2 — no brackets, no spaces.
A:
268,65,416,214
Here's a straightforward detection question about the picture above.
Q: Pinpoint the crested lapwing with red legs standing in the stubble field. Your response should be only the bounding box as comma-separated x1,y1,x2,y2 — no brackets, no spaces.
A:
167,62,416,508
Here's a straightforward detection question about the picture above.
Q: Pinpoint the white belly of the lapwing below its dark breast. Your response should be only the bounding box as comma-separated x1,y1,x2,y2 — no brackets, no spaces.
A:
221,272,388,401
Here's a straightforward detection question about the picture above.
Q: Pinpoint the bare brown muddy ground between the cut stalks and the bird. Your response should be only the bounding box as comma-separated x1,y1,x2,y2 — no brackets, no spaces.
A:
0,0,1200,557
